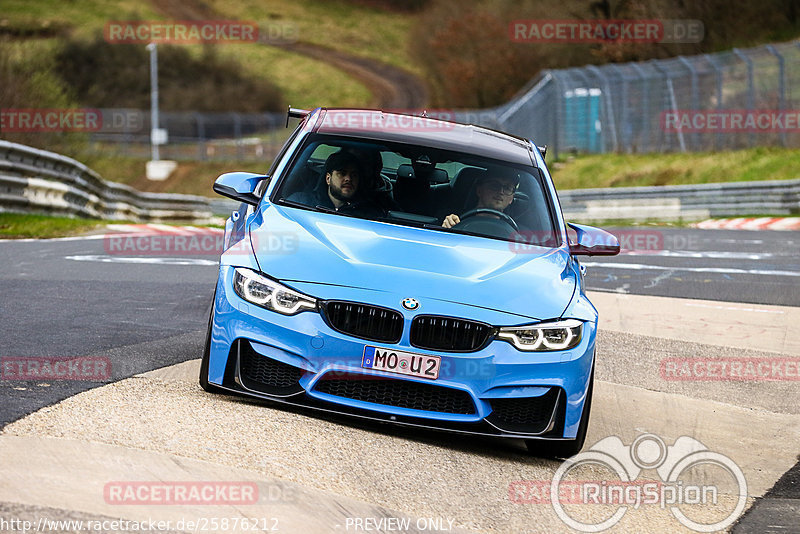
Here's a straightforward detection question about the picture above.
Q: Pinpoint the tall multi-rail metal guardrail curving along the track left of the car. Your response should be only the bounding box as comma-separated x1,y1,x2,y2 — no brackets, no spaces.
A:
0,140,212,223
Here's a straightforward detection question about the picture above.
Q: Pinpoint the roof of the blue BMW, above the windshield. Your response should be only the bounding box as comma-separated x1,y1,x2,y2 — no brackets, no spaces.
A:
308,108,534,165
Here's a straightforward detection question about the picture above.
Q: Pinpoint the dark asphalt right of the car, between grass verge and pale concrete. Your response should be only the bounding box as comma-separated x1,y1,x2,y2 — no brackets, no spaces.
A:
582,227,800,306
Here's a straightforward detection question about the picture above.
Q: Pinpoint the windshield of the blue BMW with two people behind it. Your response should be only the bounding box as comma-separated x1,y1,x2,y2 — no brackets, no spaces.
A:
273,134,559,246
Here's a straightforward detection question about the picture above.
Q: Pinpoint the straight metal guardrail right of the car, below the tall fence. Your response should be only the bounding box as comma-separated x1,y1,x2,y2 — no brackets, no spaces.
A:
555,180,800,221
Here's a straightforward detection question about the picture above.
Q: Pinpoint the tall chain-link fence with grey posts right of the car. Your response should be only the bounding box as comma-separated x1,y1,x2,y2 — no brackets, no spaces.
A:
457,41,800,158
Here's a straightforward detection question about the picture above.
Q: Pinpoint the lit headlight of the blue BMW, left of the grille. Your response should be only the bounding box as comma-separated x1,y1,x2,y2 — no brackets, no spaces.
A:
233,267,317,315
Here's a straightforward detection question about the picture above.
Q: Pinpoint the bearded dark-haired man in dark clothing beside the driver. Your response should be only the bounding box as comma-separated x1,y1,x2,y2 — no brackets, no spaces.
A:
288,150,385,217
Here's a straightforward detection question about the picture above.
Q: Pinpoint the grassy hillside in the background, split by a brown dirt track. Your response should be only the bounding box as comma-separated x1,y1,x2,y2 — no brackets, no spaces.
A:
0,0,424,107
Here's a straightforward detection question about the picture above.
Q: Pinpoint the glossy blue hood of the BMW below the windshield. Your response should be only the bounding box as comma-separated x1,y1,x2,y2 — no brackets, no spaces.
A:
249,205,576,319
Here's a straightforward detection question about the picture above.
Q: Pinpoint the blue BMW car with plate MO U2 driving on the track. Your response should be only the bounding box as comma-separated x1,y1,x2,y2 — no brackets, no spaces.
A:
200,108,619,457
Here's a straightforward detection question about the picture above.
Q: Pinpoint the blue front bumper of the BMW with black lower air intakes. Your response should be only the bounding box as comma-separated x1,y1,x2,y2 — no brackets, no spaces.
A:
208,266,596,440
